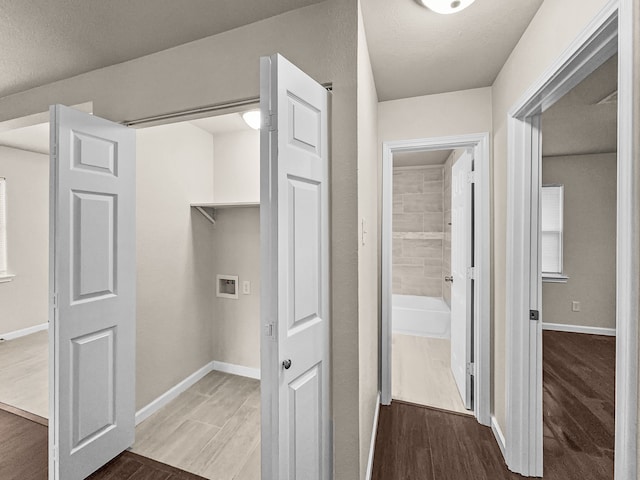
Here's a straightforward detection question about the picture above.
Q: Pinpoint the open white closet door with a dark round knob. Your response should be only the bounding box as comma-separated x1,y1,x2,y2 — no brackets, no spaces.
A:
260,55,331,480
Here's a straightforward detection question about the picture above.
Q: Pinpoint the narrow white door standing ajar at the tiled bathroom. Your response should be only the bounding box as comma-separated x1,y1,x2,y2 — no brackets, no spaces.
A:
451,150,473,409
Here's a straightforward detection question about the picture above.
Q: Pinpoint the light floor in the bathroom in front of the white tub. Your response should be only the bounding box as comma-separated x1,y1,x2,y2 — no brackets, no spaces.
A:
391,333,472,415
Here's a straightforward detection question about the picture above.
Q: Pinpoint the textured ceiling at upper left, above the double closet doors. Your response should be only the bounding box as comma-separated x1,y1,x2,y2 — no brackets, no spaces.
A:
0,0,320,97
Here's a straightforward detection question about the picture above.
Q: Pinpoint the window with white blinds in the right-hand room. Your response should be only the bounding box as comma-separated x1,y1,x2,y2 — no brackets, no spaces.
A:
540,185,564,277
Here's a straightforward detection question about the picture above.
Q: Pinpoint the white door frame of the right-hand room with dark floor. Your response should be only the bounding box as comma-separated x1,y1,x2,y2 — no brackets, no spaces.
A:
505,0,640,480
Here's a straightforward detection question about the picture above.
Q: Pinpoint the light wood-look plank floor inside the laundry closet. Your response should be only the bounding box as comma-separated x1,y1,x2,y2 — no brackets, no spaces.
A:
132,371,260,480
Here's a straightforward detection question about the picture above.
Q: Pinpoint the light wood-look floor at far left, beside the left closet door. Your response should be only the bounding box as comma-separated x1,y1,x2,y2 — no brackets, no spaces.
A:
0,330,49,418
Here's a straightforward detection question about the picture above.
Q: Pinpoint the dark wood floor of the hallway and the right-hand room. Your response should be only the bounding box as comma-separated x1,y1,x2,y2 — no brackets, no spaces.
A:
373,331,615,480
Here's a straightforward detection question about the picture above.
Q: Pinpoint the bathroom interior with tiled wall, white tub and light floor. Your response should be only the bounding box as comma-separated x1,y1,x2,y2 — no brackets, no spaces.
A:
392,148,472,414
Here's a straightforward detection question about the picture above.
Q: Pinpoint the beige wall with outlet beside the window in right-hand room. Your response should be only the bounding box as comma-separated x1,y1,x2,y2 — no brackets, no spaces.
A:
542,153,617,328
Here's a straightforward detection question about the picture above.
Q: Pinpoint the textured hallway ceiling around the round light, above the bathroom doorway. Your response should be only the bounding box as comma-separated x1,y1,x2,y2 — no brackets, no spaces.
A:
362,0,542,101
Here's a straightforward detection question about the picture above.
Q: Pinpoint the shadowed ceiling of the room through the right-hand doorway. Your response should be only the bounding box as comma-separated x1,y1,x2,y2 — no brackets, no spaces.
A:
542,55,618,156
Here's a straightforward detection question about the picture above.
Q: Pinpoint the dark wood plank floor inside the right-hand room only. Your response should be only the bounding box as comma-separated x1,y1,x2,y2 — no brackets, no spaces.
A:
542,331,616,480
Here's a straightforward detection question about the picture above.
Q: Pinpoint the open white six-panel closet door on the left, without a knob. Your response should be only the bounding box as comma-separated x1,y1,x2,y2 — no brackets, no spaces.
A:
49,105,136,480
